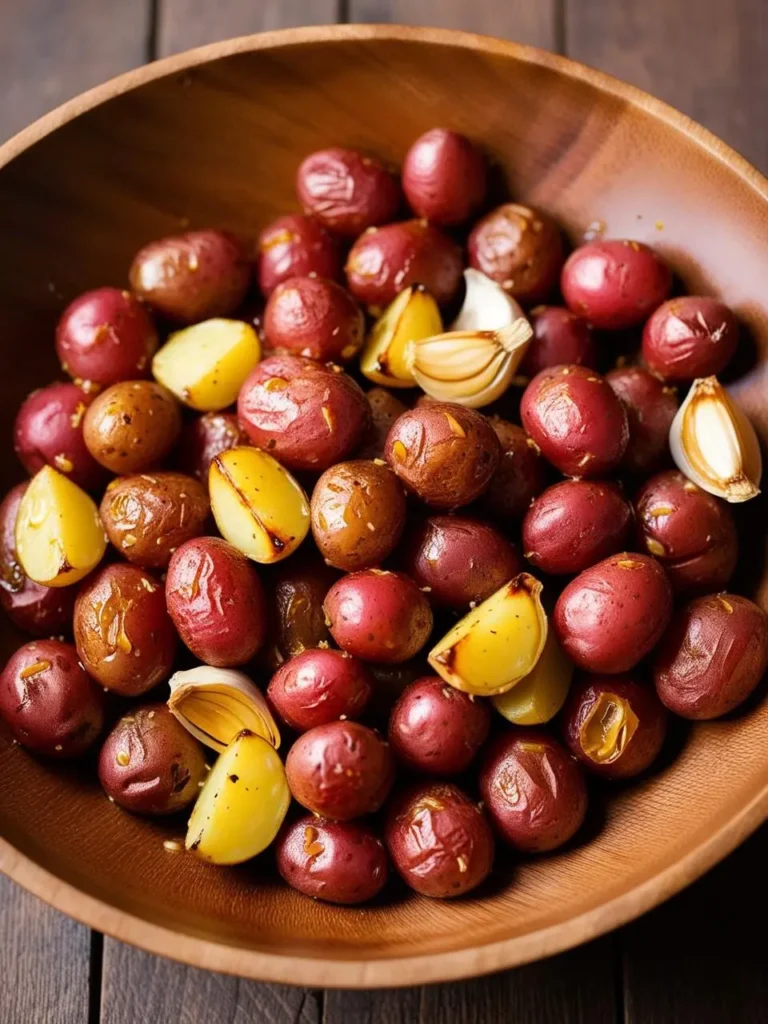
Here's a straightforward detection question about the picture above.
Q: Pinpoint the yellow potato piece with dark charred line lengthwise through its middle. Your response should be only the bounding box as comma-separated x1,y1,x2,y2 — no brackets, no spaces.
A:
208,447,309,563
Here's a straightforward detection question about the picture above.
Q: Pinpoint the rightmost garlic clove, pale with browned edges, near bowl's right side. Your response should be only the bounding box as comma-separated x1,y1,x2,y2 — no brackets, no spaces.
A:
670,377,763,502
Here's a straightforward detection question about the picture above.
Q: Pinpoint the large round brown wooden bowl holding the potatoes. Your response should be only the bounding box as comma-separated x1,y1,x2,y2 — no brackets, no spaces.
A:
0,27,768,987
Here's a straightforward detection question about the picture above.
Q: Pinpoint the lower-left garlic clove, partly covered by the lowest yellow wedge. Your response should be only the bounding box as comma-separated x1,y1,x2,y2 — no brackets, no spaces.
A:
168,665,280,753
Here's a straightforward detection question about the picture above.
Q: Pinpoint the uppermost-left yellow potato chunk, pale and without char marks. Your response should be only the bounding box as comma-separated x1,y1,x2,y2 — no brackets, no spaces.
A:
152,319,261,413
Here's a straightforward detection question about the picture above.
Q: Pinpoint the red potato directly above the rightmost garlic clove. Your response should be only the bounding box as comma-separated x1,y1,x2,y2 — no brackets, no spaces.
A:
642,295,739,382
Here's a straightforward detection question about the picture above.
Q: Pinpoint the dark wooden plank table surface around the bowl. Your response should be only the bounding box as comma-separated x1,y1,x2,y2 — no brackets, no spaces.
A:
0,0,768,1024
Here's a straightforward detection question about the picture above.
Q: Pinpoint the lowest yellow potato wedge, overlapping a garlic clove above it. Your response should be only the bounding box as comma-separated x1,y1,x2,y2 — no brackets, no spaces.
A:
186,731,291,864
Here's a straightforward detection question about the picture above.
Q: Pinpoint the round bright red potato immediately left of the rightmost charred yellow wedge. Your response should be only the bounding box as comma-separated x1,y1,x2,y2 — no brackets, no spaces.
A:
324,569,432,665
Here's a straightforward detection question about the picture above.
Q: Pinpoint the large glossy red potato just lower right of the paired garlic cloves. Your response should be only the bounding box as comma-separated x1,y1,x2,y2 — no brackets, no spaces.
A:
520,366,630,478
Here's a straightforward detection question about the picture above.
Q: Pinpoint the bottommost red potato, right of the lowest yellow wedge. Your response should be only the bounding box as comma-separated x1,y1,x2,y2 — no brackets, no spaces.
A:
275,814,389,906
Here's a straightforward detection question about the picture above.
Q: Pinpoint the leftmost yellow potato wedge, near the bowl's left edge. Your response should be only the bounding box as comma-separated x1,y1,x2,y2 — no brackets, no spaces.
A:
15,466,106,587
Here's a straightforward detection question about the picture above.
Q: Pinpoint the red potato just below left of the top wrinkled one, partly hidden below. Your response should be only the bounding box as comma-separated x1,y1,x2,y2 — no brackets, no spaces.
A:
258,213,341,298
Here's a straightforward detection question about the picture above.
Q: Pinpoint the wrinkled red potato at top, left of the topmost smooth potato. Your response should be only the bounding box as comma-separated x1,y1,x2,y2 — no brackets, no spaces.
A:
296,146,400,238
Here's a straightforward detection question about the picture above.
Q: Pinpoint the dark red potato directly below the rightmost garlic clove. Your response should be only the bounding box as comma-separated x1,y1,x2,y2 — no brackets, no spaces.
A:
635,470,738,596
